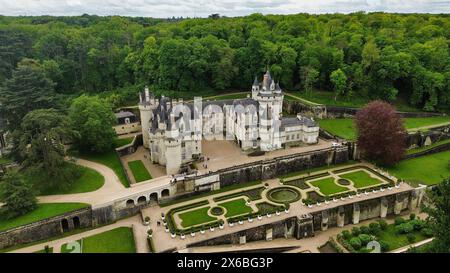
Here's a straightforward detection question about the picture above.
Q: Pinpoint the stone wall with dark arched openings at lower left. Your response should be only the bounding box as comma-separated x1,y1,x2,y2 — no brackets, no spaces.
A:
0,207,92,249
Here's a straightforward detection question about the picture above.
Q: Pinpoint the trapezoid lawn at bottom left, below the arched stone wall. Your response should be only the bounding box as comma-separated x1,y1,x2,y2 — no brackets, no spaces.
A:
83,227,136,253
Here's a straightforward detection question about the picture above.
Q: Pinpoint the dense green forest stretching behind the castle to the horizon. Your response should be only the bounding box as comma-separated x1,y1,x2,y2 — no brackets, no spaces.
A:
0,12,450,111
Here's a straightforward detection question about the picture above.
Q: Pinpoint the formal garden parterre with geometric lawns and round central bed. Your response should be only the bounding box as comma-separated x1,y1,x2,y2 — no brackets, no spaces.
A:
163,164,396,236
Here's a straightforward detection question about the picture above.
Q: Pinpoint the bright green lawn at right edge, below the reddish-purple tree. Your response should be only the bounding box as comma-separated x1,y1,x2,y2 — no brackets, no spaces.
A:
387,151,450,185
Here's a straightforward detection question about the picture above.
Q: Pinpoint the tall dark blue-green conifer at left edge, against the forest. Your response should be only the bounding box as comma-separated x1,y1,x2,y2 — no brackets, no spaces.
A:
0,59,55,129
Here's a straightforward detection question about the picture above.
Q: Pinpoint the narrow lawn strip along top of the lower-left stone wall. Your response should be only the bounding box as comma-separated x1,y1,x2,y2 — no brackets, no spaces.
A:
0,203,89,231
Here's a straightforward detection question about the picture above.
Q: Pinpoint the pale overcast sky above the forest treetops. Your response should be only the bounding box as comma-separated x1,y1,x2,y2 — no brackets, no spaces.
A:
0,0,450,18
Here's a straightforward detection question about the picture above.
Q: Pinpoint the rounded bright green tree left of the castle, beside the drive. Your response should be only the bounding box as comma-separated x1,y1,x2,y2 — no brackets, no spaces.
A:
69,95,116,152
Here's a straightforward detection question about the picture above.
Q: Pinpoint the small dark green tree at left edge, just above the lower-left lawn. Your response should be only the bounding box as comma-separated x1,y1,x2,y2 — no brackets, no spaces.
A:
0,173,37,219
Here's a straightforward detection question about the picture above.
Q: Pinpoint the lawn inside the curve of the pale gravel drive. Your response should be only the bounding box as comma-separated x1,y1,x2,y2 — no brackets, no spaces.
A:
40,165,105,195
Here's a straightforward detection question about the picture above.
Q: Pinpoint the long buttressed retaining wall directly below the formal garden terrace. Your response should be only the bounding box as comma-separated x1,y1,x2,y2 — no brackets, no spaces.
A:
187,189,423,247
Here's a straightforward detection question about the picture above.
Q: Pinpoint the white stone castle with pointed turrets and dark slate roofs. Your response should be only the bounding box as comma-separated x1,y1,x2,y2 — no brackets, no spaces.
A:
139,71,319,174
